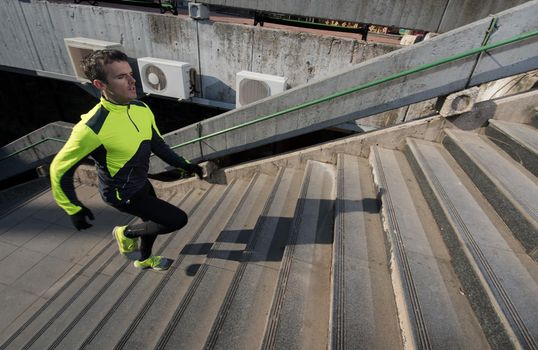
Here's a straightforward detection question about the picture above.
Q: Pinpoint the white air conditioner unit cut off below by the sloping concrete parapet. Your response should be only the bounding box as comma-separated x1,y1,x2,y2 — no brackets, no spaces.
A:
235,71,288,107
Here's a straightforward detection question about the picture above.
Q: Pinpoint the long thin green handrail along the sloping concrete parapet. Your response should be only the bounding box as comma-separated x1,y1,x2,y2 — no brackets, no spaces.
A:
172,30,538,149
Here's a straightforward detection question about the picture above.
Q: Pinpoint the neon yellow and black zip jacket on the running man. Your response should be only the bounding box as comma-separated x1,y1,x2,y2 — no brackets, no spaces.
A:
50,97,189,215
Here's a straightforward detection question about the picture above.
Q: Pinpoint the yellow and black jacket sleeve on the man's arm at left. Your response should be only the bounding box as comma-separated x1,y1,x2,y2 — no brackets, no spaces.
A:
50,122,101,215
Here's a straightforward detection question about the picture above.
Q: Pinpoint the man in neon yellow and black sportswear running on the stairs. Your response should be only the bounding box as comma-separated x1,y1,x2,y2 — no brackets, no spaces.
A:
50,50,202,270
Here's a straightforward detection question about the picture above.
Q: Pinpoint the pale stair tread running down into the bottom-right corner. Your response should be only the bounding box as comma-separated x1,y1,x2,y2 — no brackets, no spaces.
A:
408,140,538,343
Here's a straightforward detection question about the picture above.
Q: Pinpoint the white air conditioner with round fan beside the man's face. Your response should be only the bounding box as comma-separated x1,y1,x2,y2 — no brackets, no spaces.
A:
138,57,192,100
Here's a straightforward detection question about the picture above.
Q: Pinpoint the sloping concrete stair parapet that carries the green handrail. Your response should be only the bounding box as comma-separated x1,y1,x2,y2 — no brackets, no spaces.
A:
153,0,538,169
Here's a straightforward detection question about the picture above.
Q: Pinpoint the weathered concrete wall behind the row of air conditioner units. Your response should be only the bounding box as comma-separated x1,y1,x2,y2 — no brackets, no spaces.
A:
0,0,397,103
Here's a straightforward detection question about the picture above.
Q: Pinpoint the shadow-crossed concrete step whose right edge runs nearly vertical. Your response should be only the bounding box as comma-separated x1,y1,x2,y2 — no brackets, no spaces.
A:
262,161,335,349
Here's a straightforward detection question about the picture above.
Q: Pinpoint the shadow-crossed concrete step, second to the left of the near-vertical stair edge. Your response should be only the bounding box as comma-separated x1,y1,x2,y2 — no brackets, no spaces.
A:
204,168,303,350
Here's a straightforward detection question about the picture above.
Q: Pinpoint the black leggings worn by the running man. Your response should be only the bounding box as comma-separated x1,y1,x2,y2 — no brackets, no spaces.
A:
116,181,188,260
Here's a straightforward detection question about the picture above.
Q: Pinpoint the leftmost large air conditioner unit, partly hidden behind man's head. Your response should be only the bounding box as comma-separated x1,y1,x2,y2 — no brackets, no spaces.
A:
64,37,123,81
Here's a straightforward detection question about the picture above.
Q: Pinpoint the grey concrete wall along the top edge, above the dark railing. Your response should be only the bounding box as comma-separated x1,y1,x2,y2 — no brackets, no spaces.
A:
197,0,525,33
